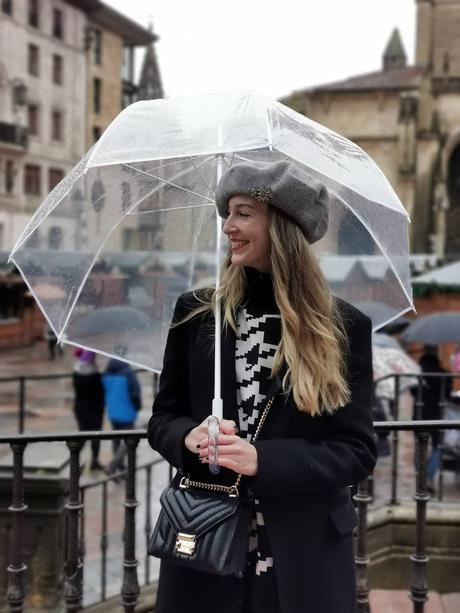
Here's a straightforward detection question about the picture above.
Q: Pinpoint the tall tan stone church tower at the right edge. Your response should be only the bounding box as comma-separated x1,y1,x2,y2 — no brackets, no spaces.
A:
415,0,460,258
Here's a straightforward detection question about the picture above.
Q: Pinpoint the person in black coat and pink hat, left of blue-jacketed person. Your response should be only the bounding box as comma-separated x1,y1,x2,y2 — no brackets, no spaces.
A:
73,348,104,470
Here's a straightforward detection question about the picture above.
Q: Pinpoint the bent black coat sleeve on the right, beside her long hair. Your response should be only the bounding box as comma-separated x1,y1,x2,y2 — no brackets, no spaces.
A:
253,311,377,497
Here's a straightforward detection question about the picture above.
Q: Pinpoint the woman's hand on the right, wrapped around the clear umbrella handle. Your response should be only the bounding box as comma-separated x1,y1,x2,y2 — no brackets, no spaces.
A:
199,420,257,477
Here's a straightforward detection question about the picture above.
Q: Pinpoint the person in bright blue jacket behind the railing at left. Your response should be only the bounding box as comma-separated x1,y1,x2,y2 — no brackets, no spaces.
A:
102,358,141,475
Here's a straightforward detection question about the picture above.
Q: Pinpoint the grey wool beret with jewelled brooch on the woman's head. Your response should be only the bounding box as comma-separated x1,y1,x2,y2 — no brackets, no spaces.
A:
216,161,329,244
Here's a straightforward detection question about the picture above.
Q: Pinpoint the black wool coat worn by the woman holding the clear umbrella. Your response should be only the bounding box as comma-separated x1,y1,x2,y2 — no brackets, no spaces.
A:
148,294,376,613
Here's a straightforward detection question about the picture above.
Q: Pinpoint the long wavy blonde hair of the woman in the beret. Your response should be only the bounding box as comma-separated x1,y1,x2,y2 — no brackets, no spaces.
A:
176,207,350,415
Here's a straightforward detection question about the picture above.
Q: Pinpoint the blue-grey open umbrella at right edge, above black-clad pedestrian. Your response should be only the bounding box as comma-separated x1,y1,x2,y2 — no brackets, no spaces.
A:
401,311,460,345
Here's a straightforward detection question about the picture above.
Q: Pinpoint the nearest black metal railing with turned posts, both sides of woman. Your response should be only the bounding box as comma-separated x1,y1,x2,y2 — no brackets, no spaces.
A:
0,420,460,613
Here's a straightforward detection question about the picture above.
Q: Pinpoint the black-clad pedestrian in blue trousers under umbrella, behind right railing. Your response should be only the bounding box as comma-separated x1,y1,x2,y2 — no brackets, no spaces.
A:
411,345,452,494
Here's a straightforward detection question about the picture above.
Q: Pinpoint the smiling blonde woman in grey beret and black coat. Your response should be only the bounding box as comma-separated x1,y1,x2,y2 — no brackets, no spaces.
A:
148,162,376,613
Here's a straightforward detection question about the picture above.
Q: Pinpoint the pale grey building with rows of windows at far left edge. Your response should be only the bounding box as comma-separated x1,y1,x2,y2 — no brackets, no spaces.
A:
0,0,86,250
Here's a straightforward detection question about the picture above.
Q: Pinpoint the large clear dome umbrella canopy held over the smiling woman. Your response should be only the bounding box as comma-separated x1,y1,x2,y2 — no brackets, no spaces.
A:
11,93,412,371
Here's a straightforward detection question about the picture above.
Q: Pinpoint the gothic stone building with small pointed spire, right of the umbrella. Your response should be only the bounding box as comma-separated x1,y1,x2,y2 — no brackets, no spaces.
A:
282,0,460,259
